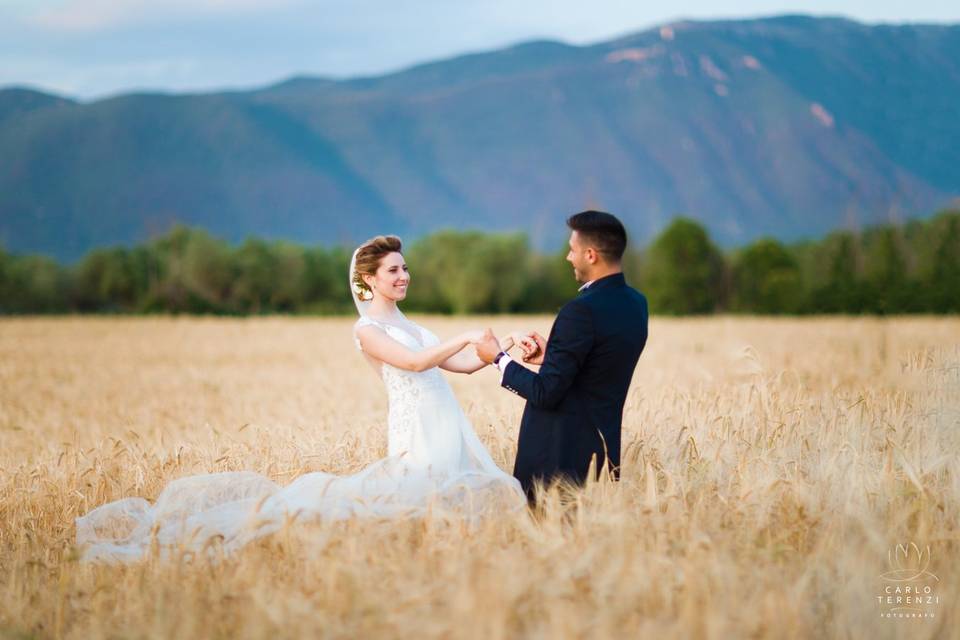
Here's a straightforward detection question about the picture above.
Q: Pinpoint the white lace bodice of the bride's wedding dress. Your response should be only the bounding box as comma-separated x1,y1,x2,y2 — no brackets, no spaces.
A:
354,317,452,456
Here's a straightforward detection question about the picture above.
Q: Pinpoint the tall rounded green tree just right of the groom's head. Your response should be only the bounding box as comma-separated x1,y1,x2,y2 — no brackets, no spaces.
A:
641,218,724,314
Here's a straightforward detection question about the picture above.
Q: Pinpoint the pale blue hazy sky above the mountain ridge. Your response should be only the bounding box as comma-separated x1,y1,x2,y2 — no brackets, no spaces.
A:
0,0,960,98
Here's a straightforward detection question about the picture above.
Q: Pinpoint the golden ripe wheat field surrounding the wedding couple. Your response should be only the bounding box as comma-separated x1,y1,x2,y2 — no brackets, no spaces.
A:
0,317,960,639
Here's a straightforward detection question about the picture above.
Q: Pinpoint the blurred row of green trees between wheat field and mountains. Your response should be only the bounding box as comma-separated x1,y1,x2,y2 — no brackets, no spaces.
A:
0,211,960,315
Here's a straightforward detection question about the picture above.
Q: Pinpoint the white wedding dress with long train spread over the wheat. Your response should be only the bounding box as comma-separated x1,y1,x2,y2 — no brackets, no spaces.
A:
76,314,526,562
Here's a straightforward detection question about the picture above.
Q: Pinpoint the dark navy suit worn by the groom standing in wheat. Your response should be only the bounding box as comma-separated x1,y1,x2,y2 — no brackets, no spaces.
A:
501,273,647,497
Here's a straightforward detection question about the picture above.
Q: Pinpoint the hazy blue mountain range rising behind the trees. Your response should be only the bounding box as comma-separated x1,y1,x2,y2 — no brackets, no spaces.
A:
0,16,960,261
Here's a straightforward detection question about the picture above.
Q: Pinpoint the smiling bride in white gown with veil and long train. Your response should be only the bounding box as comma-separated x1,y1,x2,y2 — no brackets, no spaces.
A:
76,236,526,562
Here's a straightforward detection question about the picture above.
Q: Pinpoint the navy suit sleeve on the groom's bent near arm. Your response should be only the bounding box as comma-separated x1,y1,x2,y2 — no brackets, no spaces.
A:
500,304,593,409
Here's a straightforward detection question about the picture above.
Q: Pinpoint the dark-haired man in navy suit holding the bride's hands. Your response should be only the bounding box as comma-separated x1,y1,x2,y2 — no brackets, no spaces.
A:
477,211,647,500
